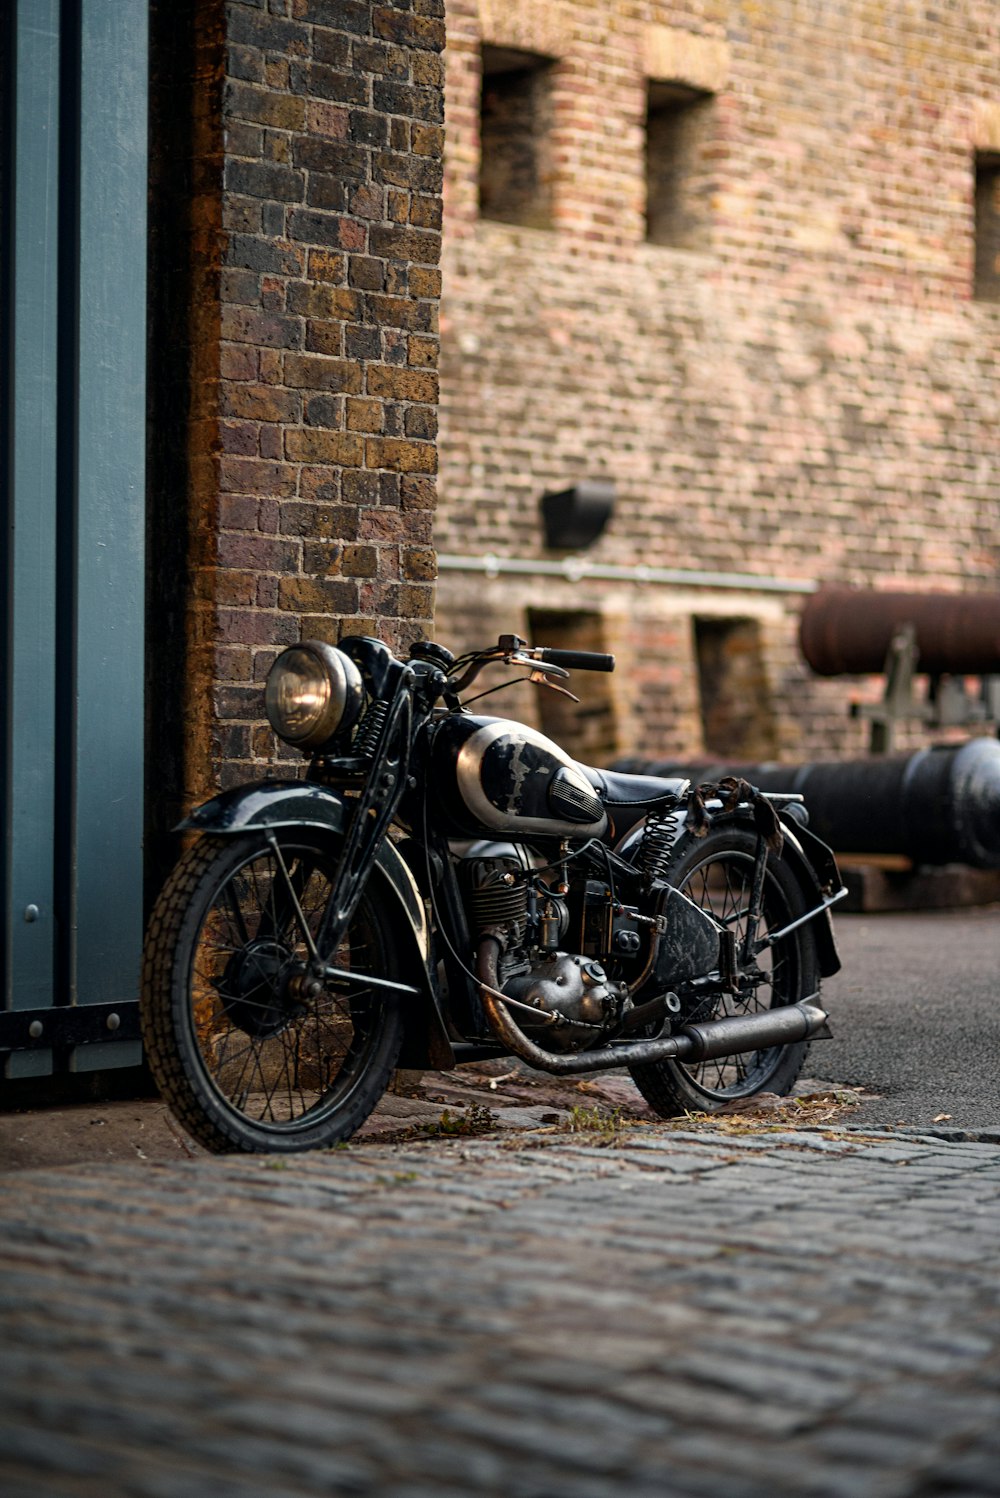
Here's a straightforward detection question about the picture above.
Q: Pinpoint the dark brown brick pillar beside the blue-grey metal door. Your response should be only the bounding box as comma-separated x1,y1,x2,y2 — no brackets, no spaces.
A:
150,0,445,874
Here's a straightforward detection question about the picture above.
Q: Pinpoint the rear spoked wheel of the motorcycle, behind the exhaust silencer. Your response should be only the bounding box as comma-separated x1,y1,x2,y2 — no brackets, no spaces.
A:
630,828,819,1118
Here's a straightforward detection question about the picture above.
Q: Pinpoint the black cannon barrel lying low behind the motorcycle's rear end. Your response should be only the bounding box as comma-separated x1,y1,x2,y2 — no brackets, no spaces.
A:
614,739,1000,869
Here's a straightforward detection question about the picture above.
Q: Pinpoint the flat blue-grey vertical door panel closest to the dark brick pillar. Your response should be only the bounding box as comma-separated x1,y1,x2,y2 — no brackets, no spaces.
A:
72,0,148,1004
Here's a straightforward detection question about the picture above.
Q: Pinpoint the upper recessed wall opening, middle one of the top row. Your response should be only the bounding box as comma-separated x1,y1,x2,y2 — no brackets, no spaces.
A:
645,82,716,250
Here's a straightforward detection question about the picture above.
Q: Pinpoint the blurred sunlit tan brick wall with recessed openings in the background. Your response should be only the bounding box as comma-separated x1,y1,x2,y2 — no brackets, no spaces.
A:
436,0,1000,758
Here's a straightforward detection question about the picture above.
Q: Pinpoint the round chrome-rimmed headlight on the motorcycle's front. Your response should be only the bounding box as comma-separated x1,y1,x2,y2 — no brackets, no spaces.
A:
263,640,364,749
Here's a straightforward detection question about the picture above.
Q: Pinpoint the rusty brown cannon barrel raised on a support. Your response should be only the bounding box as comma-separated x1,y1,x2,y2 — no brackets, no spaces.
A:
799,587,1000,676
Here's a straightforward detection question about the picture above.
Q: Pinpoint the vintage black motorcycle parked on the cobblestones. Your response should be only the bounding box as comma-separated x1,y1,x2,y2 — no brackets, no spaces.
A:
142,635,846,1150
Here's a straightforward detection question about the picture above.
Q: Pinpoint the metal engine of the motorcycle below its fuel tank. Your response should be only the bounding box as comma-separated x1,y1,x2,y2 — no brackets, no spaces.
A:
463,843,656,1050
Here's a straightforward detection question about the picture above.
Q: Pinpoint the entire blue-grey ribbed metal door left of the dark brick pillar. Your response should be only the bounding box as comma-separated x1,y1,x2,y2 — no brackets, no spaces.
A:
0,0,148,1077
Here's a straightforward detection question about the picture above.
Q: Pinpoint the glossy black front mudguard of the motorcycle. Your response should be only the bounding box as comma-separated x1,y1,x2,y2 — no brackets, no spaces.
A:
177,780,455,1071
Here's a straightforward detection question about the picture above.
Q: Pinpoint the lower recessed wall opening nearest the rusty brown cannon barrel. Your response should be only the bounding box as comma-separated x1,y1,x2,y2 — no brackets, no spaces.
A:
695,619,778,759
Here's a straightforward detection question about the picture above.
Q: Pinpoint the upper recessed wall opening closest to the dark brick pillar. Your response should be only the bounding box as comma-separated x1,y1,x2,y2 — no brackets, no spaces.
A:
479,46,552,229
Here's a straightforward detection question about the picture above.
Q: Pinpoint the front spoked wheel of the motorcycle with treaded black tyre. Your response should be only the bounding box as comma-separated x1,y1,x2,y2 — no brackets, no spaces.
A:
142,831,403,1152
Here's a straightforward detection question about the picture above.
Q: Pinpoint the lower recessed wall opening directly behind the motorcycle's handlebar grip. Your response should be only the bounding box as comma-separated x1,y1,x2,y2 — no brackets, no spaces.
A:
528,608,623,764
